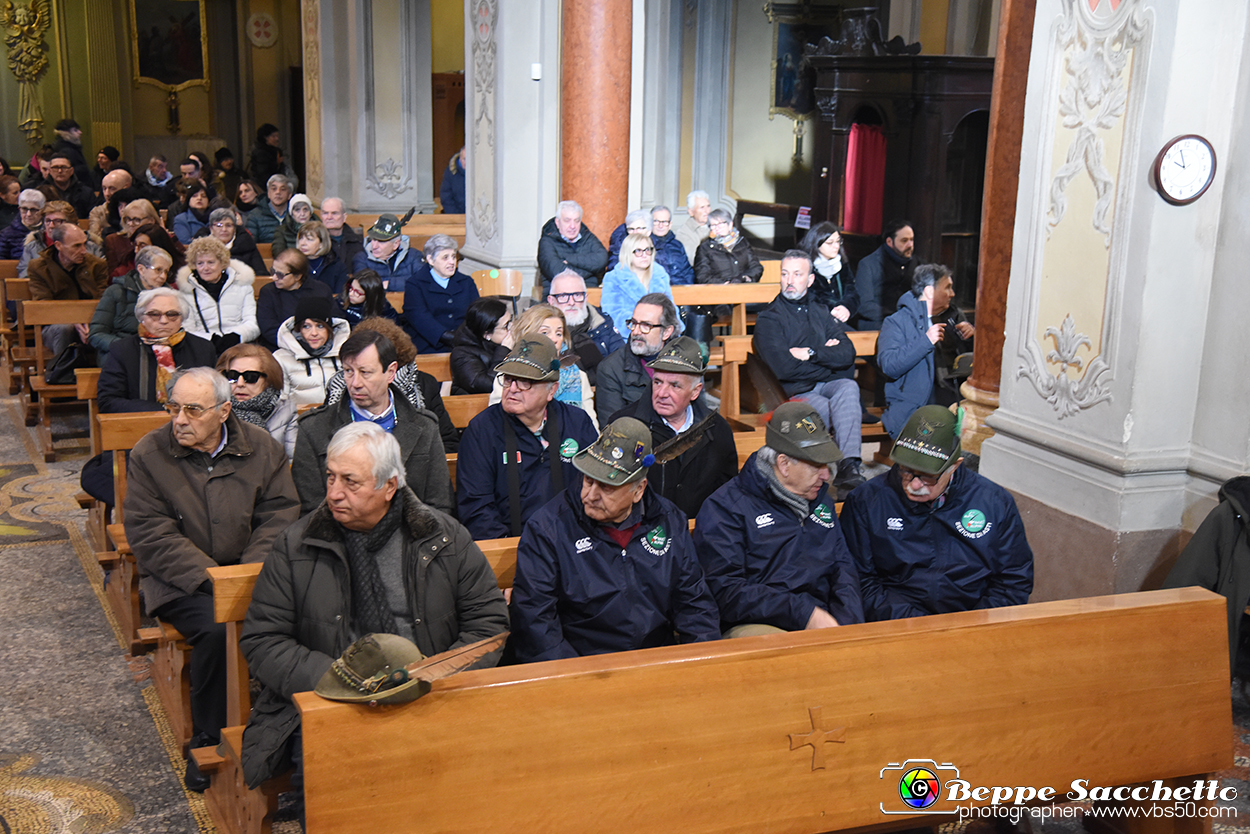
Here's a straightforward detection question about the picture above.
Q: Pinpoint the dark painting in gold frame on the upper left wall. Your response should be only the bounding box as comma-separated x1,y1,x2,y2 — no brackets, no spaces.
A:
130,0,209,93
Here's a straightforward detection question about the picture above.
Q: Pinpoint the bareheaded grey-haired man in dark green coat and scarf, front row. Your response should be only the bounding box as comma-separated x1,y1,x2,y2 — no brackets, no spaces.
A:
239,423,508,786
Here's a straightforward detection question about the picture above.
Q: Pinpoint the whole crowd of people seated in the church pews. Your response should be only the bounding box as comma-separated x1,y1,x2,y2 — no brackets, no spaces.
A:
19,151,1015,790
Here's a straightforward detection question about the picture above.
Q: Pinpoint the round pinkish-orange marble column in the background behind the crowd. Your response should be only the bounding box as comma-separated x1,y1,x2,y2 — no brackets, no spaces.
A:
560,0,634,244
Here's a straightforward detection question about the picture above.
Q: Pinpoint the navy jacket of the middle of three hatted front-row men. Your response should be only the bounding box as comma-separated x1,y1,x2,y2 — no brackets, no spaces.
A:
694,455,864,631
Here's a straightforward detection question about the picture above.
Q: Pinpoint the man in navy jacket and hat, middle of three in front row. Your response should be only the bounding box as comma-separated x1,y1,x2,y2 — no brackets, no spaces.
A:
695,403,864,638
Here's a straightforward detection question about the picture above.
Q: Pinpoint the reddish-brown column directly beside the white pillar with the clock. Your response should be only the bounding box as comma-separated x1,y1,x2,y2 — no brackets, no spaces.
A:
960,0,1038,454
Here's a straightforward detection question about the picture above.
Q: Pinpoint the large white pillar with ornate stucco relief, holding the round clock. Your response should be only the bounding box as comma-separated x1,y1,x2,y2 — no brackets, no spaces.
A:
979,0,1250,600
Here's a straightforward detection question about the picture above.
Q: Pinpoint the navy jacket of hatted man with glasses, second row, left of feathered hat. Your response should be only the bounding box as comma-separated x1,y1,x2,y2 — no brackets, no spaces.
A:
456,400,599,540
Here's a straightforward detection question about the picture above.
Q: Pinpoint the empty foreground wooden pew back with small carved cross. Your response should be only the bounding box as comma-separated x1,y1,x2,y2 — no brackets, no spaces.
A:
295,588,1233,834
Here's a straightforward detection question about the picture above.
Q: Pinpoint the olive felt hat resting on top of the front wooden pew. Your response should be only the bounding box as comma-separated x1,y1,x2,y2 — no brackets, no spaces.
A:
313,634,430,704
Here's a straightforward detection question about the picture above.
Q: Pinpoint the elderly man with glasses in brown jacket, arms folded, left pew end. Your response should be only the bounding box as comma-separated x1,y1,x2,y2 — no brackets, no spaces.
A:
125,368,299,790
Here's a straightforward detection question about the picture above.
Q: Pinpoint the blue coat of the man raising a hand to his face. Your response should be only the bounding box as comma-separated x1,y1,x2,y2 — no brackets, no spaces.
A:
876,293,934,438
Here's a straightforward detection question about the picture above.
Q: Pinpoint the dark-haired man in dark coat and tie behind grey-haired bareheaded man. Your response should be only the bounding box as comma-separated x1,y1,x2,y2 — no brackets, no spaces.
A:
291,330,455,514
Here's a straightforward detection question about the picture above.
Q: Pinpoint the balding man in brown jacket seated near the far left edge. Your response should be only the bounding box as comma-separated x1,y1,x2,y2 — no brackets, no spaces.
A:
26,223,109,354
